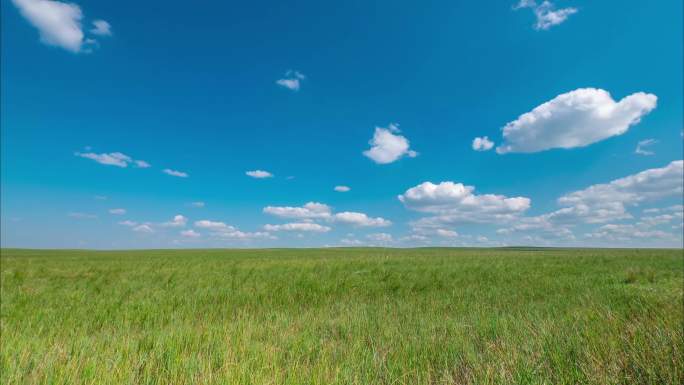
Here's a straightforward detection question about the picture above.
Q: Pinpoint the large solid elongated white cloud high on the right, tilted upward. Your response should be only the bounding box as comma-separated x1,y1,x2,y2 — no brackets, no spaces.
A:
496,88,658,154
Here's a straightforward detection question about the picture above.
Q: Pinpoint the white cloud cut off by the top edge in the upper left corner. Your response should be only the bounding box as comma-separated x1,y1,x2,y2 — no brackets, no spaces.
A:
12,0,83,52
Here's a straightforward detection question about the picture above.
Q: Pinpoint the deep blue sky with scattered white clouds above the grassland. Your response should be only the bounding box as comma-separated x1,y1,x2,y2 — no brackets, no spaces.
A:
0,0,684,248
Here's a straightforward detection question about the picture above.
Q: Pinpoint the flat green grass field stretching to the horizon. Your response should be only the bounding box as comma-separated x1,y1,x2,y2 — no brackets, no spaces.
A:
0,248,684,385
